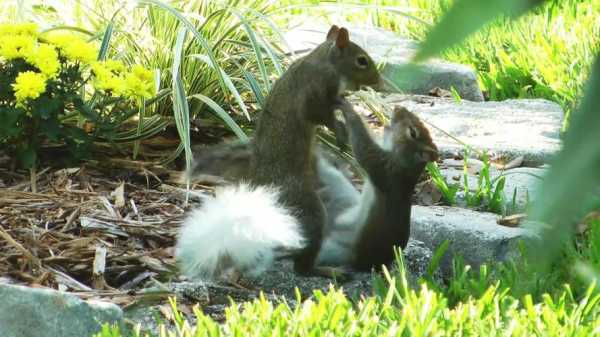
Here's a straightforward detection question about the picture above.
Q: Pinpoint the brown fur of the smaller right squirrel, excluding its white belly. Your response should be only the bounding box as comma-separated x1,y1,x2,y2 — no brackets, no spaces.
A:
344,106,438,270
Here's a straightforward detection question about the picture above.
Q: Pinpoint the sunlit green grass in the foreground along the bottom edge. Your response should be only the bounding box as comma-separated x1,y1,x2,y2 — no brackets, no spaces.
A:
97,220,600,337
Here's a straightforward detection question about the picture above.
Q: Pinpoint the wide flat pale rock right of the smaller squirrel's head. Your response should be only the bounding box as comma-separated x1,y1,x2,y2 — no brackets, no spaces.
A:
385,94,563,166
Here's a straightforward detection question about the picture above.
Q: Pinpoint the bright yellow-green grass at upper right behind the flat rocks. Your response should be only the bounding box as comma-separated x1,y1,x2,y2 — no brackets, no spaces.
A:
404,0,600,120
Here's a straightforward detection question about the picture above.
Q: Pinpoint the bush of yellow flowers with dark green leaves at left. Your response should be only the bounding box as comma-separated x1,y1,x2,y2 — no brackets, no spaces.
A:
0,23,154,167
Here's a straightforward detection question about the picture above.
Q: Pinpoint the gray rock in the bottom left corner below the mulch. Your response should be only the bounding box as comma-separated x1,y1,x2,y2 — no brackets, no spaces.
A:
0,284,123,337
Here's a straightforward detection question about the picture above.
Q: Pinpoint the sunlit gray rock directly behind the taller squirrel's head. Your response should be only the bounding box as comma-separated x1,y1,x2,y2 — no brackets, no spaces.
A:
285,24,483,101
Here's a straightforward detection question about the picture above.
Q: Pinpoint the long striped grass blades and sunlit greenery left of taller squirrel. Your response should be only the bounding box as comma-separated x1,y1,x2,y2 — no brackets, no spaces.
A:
0,0,284,161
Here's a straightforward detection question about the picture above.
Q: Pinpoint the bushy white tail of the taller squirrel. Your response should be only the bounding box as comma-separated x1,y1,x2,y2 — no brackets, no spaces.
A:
176,183,304,280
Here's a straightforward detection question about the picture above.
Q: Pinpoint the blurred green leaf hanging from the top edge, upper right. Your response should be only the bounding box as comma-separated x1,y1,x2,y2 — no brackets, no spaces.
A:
414,0,543,62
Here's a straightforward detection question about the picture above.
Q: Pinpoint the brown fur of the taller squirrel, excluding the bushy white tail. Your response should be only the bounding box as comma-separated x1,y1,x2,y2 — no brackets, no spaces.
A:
191,26,380,273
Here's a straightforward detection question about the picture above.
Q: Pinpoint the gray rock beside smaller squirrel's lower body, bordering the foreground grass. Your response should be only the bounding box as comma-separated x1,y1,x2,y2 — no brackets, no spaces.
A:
411,206,536,278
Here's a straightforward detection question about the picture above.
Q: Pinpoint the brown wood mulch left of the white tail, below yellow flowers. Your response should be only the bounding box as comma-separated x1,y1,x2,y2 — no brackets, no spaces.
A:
0,159,216,305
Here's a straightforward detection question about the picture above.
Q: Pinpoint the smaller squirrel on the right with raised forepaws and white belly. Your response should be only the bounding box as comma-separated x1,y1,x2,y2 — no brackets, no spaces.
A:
318,106,438,270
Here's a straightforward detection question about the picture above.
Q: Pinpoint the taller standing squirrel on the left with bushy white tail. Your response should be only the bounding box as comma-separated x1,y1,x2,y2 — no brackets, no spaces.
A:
177,26,380,279
